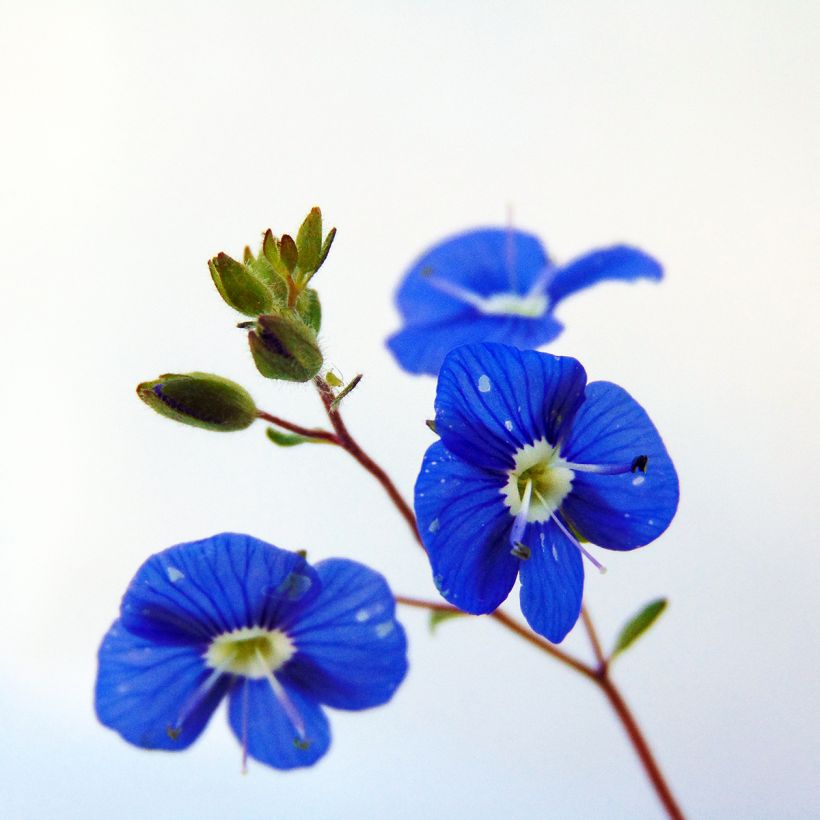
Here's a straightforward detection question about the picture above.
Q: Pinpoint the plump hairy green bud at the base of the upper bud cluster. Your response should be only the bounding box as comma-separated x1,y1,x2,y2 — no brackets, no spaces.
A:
248,315,322,382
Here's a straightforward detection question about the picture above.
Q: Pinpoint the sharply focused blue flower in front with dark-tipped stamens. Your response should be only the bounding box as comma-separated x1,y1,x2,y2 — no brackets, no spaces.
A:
415,344,678,643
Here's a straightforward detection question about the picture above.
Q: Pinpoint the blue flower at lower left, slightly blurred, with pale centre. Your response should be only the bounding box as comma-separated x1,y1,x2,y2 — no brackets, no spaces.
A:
96,533,407,769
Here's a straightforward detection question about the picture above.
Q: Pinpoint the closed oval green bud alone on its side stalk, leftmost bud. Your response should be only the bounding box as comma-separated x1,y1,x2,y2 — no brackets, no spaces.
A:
137,373,256,432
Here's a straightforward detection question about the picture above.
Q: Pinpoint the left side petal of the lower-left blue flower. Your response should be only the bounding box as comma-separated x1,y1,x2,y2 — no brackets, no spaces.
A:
95,621,230,751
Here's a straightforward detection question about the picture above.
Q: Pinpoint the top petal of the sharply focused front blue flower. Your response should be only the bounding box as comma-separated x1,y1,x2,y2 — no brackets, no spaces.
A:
436,344,586,472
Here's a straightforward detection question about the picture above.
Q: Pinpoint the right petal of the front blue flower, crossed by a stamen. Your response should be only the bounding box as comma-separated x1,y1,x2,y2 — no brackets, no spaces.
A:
562,382,678,550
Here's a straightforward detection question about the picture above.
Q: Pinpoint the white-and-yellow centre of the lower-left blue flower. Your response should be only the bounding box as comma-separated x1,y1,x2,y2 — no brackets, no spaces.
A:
205,626,296,680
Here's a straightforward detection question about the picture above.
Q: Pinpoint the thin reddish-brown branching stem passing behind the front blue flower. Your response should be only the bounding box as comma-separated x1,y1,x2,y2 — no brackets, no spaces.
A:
310,384,683,820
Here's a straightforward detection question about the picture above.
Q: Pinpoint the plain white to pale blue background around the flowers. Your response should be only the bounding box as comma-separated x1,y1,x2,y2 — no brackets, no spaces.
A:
0,0,820,820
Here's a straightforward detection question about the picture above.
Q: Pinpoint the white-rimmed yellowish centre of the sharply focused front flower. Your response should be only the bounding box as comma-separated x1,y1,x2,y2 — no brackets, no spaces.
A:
501,438,575,522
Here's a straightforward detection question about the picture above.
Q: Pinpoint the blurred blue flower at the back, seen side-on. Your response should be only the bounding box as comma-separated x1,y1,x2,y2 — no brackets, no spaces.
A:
387,228,662,375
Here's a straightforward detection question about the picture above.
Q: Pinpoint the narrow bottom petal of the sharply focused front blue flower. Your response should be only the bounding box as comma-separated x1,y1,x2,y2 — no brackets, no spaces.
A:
521,521,584,643
